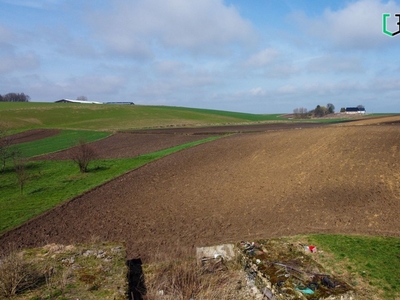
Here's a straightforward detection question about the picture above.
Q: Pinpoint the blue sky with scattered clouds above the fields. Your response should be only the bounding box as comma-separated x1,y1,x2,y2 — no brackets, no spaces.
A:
0,0,400,114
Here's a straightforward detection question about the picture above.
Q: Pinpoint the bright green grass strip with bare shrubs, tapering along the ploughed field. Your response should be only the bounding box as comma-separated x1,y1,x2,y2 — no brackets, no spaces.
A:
0,137,220,233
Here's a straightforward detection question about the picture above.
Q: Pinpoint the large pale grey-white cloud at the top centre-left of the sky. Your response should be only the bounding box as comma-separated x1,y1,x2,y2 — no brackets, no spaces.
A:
89,0,255,57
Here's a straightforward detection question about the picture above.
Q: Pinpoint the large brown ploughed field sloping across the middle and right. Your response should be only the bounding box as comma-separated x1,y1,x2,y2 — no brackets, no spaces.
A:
0,120,400,261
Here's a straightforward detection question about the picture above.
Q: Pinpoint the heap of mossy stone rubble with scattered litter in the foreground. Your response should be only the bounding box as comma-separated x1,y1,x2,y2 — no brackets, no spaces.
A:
238,239,357,300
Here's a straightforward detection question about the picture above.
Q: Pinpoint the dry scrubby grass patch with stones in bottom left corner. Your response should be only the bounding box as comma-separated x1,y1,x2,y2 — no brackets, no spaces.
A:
0,243,128,300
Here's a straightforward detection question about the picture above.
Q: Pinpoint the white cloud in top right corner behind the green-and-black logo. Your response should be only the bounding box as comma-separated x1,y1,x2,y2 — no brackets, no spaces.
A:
292,0,400,49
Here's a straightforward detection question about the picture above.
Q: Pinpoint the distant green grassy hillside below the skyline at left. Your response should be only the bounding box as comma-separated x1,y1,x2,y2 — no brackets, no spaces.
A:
0,102,284,131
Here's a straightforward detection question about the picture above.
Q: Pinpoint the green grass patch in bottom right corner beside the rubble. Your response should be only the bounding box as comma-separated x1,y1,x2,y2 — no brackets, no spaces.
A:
309,235,400,299
